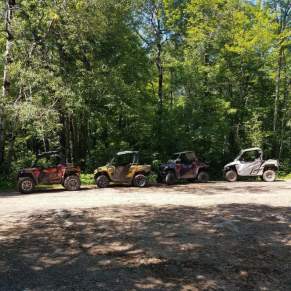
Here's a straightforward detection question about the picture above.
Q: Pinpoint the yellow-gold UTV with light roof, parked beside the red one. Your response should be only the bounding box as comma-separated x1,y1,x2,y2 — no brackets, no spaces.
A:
94,151,151,188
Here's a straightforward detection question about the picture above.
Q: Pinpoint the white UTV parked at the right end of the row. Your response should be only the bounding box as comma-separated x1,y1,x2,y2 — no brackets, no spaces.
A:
224,148,279,182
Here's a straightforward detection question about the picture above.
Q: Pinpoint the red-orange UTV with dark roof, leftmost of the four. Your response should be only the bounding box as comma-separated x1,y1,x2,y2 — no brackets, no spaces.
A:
17,152,81,194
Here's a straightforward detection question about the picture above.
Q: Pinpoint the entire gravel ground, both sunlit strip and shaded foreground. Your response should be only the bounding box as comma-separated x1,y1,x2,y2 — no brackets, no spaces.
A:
0,181,291,291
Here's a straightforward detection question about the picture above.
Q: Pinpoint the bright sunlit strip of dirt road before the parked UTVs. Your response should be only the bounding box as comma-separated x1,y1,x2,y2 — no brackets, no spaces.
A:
0,181,291,217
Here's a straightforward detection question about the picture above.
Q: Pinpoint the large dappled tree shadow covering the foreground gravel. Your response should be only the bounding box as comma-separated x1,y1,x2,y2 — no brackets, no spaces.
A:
0,204,291,291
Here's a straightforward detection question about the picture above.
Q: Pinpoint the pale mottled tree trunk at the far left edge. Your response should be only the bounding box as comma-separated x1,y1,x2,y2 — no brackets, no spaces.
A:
0,0,16,170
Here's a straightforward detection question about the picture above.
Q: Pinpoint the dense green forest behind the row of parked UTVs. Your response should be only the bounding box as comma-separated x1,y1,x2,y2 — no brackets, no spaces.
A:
0,0,291,184
